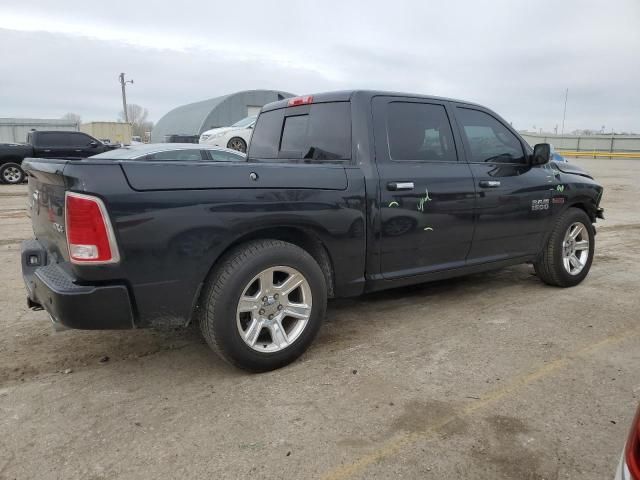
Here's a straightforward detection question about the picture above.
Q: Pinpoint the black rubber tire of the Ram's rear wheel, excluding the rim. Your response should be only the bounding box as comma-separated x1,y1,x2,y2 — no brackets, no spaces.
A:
198,240,327,372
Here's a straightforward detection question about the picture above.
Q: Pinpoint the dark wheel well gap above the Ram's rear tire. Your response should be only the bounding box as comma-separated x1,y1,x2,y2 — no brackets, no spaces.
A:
212,227,335,298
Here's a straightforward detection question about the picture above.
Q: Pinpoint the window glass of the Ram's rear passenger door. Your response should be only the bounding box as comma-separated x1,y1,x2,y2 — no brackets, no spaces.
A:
387,102,457,162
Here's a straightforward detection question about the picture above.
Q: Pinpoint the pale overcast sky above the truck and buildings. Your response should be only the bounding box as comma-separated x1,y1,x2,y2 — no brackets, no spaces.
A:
0,0,640,132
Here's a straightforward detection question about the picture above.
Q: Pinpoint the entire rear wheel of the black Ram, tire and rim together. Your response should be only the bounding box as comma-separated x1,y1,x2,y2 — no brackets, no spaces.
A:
199,240,327,372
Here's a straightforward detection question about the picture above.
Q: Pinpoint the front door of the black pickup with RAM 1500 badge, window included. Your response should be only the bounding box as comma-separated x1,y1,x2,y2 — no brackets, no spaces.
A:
455,105,552,263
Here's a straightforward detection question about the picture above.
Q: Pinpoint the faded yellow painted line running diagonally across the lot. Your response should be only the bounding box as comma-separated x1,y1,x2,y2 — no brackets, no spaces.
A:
321,329,640,480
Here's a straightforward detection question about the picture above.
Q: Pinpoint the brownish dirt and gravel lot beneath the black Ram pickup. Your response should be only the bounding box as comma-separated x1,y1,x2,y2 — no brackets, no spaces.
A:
0,159,640,480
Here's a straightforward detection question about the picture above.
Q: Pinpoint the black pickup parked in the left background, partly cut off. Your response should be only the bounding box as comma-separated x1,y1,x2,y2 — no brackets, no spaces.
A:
0,130,115,184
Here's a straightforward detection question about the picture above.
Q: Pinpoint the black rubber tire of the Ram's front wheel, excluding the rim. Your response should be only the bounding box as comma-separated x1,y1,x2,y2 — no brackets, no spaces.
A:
534,208,595,287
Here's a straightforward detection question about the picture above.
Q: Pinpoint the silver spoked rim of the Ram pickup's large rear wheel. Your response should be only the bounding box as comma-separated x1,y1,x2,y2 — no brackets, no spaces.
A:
236,266,312,353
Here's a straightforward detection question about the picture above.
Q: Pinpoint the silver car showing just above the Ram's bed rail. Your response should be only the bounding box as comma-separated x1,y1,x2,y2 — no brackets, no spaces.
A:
91,143,247,162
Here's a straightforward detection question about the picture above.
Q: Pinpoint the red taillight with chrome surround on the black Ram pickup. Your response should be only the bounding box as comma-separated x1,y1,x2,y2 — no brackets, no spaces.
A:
65,192,120,265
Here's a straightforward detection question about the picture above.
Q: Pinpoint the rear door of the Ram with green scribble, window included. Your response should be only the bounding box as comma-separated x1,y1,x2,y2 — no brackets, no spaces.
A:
373,97,475,279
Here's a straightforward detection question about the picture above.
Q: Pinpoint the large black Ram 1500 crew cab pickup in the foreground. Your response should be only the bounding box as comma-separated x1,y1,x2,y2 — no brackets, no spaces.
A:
22,91,603,371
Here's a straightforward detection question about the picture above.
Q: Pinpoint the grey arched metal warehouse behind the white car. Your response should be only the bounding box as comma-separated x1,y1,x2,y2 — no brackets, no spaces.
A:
151,90,294,142
